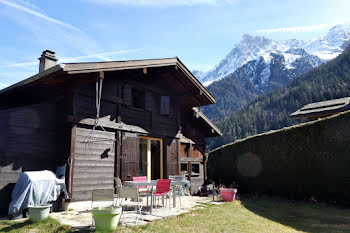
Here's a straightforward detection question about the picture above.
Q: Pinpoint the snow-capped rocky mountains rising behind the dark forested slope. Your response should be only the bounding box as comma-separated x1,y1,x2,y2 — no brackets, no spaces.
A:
194,24,350,88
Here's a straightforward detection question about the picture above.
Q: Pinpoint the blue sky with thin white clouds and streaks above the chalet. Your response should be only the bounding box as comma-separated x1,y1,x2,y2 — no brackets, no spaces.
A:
0,0,350,89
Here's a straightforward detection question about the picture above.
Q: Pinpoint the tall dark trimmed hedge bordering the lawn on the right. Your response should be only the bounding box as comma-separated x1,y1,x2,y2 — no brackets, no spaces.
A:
208,112,350,205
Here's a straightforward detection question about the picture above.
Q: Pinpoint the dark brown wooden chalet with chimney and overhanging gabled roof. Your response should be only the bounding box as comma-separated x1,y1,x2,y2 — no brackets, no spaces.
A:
0,50,221,212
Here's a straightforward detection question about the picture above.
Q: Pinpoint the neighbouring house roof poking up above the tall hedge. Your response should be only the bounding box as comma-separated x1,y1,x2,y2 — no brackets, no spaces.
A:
290,97,350,118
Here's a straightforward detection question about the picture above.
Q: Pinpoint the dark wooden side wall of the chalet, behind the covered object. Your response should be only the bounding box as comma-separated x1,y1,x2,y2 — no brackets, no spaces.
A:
0,101,63,213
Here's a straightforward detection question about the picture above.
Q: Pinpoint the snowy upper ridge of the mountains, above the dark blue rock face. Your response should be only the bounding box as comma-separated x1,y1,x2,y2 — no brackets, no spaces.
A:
198,23,350,84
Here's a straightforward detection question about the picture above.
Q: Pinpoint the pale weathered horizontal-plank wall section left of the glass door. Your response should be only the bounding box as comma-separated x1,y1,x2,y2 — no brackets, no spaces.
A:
72,127,116,201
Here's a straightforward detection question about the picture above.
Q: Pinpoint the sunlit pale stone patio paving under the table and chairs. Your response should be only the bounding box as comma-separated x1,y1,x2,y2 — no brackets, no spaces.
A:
50,196,220,229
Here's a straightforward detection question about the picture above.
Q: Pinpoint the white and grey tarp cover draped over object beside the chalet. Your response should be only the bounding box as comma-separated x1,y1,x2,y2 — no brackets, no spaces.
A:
9,170,65,214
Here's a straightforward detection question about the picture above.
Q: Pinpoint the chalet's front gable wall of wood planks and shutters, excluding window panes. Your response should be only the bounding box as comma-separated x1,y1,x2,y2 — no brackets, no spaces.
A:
72,73,211,200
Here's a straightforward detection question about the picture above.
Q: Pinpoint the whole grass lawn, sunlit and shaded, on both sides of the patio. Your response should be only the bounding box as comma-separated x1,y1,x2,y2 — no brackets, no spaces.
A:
0,198,350,232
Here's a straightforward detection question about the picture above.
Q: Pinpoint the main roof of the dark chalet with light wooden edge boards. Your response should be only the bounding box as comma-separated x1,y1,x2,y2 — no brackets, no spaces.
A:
0,57,216,104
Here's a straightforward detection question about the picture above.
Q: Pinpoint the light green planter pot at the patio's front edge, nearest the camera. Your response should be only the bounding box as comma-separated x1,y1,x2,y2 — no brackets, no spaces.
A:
91,206,122,231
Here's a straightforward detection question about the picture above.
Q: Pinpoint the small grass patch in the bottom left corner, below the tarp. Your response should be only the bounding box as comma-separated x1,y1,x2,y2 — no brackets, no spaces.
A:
0,218,74,233
